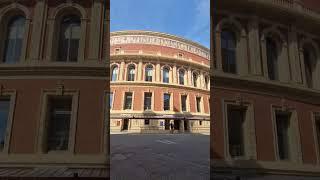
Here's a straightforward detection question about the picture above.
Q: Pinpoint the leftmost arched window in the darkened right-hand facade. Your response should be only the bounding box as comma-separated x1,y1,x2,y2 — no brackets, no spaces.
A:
221,30,237,74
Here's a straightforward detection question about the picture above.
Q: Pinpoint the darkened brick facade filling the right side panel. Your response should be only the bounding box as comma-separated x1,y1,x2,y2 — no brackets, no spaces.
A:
211,0,320,177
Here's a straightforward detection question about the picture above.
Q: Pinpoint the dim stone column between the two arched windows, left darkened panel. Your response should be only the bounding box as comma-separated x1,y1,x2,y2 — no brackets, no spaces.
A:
30,1,47,61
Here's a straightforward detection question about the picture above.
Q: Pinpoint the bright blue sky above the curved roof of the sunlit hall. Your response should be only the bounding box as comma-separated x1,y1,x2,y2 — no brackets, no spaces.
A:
110,0,210,48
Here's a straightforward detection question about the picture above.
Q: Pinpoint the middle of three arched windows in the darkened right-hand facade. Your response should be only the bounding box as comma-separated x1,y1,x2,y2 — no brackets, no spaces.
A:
266,37,279,80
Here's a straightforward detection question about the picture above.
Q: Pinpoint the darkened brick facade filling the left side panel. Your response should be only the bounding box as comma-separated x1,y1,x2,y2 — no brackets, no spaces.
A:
0,0,109,177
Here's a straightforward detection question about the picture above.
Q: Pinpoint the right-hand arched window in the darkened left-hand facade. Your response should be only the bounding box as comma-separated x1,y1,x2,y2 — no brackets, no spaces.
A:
57,16,81,62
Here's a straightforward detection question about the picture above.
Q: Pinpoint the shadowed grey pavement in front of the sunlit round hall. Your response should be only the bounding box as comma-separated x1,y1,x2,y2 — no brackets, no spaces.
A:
110,134,210,180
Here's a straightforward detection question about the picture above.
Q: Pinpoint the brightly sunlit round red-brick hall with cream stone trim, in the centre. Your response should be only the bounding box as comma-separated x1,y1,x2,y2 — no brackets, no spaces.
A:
109,31,210,133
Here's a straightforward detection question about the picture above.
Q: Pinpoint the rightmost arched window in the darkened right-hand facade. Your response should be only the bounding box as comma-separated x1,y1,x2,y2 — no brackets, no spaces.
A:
303,46,316,88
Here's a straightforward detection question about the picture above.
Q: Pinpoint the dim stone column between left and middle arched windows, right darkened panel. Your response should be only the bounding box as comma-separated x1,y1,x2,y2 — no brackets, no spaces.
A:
248,17,262,75
